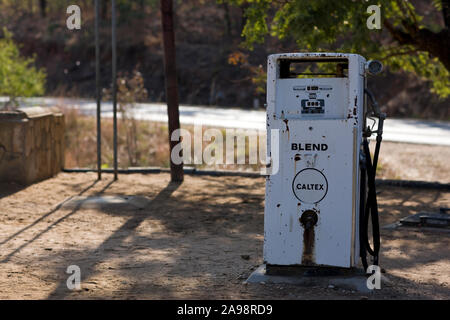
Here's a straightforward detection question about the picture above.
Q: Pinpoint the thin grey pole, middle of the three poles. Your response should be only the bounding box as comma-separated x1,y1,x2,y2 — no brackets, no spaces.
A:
111,0,117,180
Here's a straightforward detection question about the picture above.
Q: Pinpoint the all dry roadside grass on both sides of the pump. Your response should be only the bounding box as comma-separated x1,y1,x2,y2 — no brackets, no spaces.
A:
65,109,450,183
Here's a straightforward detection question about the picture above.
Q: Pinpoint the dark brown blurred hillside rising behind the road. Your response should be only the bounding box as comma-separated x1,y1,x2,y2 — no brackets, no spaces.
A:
0,0,450,120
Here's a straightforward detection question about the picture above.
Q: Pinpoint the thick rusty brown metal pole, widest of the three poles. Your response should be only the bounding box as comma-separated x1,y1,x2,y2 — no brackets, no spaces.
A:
161,0,183,181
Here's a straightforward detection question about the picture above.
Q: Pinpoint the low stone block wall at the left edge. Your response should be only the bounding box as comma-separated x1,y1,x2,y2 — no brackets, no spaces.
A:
0,107,64,185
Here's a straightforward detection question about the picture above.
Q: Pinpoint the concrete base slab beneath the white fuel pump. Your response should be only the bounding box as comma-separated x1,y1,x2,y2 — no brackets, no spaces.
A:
245,264,374,293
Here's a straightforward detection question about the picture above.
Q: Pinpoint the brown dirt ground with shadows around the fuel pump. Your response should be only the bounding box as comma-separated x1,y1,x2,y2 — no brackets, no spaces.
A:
0,173,450,299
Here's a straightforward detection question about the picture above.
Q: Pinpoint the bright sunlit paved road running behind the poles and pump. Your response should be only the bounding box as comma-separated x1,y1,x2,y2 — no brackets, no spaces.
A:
9,98,450,146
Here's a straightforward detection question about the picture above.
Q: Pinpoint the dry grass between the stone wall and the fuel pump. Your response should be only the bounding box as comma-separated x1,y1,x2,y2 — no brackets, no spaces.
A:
64,109,265,171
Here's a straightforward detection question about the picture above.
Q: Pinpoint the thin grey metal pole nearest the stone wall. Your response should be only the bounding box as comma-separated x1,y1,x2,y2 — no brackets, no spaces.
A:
95,0,102,180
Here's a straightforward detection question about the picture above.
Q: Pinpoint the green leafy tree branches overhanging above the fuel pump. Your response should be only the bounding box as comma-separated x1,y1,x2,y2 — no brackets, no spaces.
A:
229,0,450,97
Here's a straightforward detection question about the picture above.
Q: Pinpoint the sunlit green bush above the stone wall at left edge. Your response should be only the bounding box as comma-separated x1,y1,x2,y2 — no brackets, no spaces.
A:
0,29,46,107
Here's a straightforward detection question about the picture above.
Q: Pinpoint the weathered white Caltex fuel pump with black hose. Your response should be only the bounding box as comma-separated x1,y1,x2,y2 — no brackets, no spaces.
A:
264,53,385,269
